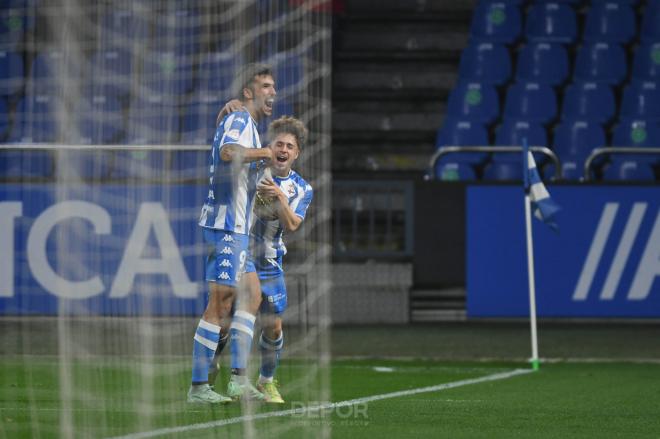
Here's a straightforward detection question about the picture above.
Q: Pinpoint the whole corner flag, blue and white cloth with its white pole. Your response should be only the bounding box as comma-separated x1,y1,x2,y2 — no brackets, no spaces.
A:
522,139,559,370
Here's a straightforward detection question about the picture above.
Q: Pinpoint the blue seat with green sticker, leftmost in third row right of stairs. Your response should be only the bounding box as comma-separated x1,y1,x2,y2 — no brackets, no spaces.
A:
447,82,500,125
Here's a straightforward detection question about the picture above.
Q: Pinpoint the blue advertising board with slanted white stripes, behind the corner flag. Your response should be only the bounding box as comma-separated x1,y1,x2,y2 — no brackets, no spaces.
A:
466,186,660,318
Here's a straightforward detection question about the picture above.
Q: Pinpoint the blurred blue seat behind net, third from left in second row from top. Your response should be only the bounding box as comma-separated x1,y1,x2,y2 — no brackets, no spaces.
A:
87,48,133,98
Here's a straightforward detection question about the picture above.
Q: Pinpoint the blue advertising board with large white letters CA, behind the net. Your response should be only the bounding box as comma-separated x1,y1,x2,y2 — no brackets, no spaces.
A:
0,184,207,315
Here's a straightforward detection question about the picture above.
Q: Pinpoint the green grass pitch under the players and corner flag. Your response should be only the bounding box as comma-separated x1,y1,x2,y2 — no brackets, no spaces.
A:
0,356,660,439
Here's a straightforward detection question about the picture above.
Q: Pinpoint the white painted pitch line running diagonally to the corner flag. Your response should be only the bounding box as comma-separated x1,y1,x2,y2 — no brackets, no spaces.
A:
107,369,533,439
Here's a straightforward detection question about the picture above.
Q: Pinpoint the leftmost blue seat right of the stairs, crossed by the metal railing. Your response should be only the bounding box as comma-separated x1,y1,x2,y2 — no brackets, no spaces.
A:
435,118,490,164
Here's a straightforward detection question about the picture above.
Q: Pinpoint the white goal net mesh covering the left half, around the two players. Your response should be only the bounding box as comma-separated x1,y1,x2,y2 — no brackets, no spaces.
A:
0,0,330,437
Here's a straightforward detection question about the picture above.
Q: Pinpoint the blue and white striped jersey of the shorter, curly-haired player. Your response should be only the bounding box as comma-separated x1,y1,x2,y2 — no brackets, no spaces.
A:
251,170,314,259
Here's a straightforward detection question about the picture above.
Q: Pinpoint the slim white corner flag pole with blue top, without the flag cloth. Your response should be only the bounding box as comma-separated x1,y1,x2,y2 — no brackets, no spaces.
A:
523,139,539,370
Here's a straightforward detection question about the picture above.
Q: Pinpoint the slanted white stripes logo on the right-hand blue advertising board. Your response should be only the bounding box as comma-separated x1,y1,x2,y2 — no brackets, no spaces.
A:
573,203,660,301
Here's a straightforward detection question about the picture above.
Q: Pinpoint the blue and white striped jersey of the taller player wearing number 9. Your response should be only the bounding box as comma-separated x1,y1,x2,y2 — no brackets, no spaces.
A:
199,111,263,235
